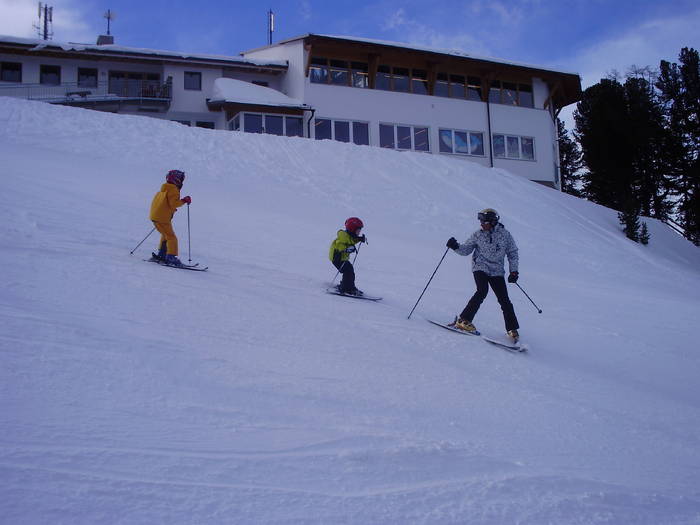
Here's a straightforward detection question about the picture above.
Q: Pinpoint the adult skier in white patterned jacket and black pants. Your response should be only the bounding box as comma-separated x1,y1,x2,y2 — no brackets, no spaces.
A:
447,208,520,342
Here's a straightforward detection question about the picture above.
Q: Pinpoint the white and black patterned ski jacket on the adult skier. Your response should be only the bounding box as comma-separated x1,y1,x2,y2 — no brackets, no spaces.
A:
455,223,518,277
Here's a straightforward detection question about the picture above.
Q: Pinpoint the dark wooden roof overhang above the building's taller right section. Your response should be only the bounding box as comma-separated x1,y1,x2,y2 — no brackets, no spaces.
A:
304,35,581,111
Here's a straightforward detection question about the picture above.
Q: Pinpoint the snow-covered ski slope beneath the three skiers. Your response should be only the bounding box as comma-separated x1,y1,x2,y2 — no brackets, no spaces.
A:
0,98,700,524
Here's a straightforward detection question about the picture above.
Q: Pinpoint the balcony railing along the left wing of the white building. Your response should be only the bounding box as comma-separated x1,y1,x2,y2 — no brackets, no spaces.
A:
0,79,172,105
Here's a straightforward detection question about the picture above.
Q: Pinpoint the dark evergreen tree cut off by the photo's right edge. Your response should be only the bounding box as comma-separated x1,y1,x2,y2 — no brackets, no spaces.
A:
656,47,700,246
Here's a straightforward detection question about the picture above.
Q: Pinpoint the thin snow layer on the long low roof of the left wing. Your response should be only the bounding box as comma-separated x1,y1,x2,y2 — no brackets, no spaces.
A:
0,35,288,68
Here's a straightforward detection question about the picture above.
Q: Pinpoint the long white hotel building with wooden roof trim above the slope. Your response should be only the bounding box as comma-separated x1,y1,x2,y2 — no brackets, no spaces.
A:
0,34,581,188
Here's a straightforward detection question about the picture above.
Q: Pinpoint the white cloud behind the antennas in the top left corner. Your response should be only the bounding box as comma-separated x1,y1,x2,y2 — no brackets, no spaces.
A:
0,0,97,42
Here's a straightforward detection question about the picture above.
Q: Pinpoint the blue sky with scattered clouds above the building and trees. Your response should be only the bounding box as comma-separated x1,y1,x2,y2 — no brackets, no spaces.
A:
0,0,700,97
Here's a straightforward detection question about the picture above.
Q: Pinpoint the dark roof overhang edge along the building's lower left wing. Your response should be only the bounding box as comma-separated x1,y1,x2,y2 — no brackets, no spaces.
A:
0,42,288,75
